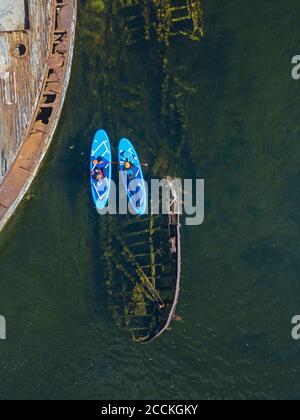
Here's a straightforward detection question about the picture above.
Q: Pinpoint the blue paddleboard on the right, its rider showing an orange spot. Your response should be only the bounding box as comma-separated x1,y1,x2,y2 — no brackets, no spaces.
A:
119,139,148,216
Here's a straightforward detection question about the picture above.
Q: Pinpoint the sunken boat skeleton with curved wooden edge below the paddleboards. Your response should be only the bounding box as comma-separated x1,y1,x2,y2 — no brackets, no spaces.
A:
103,179,181,343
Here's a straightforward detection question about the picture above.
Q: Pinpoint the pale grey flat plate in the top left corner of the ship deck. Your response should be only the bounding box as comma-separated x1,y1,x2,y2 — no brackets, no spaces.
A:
0,0,26,32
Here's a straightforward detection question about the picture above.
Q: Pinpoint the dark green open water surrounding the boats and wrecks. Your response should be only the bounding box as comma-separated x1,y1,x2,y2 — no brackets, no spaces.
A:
0,0,300,399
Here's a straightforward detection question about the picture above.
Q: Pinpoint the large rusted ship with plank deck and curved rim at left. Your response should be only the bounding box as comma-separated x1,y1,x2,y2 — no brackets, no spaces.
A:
0,0,77,230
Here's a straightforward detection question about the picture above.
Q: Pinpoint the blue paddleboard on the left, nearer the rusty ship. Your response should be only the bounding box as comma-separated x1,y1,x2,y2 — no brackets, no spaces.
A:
90,130,112,212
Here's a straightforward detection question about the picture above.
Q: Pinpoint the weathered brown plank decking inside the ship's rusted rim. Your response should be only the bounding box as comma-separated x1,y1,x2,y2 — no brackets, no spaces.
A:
0,0,53,182
